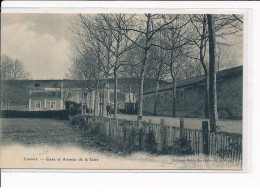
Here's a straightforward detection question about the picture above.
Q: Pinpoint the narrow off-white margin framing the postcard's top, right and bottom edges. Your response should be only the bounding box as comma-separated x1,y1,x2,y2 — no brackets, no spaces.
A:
0,5,251,172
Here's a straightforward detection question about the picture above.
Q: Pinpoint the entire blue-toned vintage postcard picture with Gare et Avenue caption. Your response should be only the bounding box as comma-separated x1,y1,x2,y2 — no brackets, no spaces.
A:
0,12,244,171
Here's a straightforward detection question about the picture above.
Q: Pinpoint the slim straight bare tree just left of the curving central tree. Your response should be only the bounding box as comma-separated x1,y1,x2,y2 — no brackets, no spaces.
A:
71,14,135,118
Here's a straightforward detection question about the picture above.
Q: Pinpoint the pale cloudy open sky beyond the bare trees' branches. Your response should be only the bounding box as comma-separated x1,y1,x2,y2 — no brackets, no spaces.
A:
1,13,242,79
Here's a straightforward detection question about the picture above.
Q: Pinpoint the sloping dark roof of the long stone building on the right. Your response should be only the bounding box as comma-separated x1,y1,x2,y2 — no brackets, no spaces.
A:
144,66,243,94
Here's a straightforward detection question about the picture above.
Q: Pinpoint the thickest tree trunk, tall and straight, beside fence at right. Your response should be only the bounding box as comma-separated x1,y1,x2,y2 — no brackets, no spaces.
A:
207,14,218,131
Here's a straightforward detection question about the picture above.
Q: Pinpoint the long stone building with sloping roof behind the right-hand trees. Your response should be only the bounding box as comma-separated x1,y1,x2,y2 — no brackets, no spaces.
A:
143,66,243,119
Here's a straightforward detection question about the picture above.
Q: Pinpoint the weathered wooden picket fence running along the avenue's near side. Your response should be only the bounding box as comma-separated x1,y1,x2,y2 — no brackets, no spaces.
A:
78,117,242,164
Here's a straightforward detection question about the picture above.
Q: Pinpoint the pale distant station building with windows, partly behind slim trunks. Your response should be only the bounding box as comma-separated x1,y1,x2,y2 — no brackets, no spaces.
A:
28,81,131,115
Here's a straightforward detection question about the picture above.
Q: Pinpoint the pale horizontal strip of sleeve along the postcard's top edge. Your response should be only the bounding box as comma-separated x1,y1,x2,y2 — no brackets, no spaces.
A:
2,6,248,14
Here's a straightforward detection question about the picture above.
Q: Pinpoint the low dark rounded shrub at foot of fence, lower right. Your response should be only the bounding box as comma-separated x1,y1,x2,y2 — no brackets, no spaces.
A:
165,138,193,155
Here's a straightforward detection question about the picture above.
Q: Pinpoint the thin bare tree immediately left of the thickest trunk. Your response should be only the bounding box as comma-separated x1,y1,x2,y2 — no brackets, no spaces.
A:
186,14,243,118
